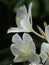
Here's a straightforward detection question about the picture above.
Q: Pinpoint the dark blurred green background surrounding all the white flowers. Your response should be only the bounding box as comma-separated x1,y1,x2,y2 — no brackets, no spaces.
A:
0,0,49,65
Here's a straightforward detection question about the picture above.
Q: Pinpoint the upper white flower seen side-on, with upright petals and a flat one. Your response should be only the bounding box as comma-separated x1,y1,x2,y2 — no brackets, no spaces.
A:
7,3,32,33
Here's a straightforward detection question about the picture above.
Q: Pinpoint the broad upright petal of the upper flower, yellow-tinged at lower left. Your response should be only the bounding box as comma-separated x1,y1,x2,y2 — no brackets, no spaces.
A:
16,5,27,27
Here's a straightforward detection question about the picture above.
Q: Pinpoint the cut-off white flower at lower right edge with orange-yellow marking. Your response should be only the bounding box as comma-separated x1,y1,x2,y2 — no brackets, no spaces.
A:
40,42,49,63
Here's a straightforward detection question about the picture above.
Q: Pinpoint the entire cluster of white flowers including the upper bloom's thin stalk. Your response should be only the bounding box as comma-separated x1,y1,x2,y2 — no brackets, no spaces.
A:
7,2,49,65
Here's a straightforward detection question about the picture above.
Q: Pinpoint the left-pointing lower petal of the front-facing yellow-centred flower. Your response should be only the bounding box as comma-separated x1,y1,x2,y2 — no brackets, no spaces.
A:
10,44,24,56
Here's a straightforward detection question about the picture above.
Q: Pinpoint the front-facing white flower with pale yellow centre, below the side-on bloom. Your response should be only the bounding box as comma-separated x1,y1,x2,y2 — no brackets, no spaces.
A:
10,33,40,63
